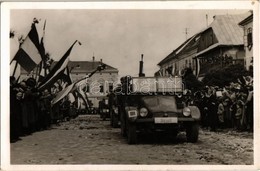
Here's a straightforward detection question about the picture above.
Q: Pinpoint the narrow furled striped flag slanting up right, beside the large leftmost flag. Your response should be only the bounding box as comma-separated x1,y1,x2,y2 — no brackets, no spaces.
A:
38,40,77,91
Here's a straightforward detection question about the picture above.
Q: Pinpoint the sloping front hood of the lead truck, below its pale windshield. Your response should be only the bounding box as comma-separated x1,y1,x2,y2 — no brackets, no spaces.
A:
142,96,177,112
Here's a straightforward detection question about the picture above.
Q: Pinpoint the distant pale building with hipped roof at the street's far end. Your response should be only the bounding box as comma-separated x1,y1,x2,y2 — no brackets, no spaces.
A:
20,57,119,107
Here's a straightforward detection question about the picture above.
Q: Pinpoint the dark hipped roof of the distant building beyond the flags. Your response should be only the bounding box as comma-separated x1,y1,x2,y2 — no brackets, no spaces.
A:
52,61,118,73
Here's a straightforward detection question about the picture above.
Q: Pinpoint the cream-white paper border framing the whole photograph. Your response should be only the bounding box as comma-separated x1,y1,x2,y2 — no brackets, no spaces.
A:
1,1,260,170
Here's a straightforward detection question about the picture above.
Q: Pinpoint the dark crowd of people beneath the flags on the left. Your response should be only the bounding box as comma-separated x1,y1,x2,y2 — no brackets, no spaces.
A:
10,76,76,142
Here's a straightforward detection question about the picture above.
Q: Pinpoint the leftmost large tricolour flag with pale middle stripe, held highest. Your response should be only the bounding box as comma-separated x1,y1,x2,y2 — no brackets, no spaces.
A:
12,23,42,72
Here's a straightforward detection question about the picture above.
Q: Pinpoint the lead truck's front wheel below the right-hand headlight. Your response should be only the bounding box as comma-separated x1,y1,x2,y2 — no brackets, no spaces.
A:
186,123,199,143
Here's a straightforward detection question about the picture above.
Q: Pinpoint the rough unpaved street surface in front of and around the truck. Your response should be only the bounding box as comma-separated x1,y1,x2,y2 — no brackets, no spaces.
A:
11,115,253,165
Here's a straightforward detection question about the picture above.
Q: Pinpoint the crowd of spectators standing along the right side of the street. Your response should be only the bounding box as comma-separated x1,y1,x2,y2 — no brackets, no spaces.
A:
191,76,254,132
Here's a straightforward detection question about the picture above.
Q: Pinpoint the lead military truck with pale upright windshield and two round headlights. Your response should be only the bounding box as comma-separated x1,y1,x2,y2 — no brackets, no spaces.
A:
109,54,200,144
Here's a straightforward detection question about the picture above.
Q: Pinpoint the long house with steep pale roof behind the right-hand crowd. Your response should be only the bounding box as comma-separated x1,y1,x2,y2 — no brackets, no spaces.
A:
155,13,250,77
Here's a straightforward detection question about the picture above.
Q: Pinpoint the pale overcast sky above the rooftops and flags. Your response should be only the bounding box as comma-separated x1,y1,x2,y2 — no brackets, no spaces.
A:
10,5,248,76
